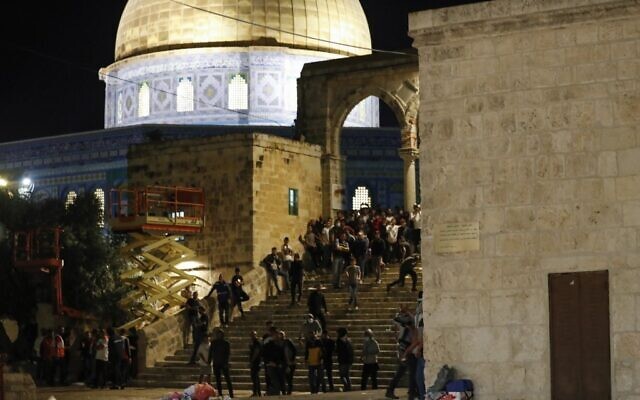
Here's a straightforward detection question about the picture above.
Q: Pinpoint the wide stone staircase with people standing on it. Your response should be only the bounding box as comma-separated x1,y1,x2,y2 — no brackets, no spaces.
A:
133,264,422,392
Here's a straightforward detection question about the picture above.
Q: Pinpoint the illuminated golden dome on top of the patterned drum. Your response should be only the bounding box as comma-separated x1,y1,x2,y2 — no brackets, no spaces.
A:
115,0,371,60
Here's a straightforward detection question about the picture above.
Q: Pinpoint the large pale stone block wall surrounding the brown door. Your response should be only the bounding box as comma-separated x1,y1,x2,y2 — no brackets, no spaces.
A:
410,0,640,400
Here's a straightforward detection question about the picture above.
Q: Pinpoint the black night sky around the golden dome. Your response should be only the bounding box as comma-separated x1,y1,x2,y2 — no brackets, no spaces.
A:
0,0,477,142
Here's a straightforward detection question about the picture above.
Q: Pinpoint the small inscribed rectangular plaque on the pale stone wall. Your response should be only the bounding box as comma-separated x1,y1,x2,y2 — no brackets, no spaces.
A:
435,222,480,253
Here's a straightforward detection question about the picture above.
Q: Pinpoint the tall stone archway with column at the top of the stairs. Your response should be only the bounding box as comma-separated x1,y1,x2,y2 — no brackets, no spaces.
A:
296,54,420,215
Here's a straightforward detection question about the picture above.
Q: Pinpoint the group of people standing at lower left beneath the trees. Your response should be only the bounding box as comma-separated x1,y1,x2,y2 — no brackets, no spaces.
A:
34,327,138,389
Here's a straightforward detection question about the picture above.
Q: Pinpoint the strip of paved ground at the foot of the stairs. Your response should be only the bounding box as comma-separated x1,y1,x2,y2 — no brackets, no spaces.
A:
38,386,385,400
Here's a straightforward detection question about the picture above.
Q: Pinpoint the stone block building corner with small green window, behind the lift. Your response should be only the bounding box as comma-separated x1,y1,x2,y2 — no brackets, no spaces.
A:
128,134,321,276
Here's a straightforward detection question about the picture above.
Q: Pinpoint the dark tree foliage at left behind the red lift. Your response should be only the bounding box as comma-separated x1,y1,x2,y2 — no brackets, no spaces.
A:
0,191,126,322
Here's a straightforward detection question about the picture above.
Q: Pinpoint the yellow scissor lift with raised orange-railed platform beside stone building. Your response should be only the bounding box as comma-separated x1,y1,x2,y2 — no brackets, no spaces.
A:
109,186,205,329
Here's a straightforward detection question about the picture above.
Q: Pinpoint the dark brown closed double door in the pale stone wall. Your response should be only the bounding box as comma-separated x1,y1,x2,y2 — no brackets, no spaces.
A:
549,271,611,400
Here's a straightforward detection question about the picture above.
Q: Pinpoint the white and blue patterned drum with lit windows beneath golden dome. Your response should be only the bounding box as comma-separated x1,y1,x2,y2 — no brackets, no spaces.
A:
100,47,379,128
